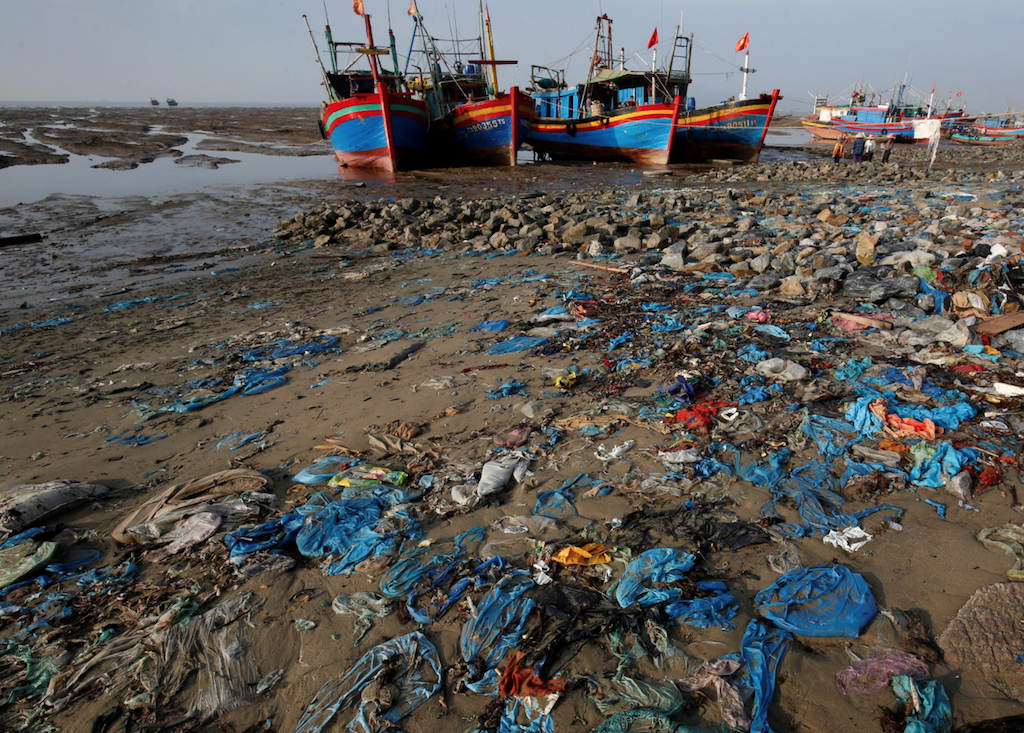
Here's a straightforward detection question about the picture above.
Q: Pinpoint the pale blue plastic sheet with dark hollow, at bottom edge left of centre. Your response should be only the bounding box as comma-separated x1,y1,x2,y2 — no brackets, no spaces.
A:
295,632,442,733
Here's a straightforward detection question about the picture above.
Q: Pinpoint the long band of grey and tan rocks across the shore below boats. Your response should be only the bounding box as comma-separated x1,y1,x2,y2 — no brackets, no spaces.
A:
276,177,1024,313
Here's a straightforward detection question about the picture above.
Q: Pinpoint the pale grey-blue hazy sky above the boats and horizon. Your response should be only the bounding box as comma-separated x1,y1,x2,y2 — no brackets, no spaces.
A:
0,0,1024,113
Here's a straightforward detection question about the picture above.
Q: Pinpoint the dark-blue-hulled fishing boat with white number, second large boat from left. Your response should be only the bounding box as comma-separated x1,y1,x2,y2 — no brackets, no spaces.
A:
406,3,534,166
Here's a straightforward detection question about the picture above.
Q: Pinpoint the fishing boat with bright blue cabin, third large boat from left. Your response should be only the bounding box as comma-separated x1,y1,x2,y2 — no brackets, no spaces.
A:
528,15,681,166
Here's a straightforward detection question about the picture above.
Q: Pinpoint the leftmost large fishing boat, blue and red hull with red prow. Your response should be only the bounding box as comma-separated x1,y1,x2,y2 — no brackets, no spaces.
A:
303,8,429,173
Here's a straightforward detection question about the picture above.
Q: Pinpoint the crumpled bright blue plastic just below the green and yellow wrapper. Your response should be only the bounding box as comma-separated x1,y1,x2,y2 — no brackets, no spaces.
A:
295,498,423,575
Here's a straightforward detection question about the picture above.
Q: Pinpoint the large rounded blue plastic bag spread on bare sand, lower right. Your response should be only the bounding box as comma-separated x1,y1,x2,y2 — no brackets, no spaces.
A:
754,565,879,639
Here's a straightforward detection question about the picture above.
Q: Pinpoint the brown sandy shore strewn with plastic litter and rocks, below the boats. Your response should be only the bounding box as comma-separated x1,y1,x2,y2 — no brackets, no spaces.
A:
0,139,1024,733
